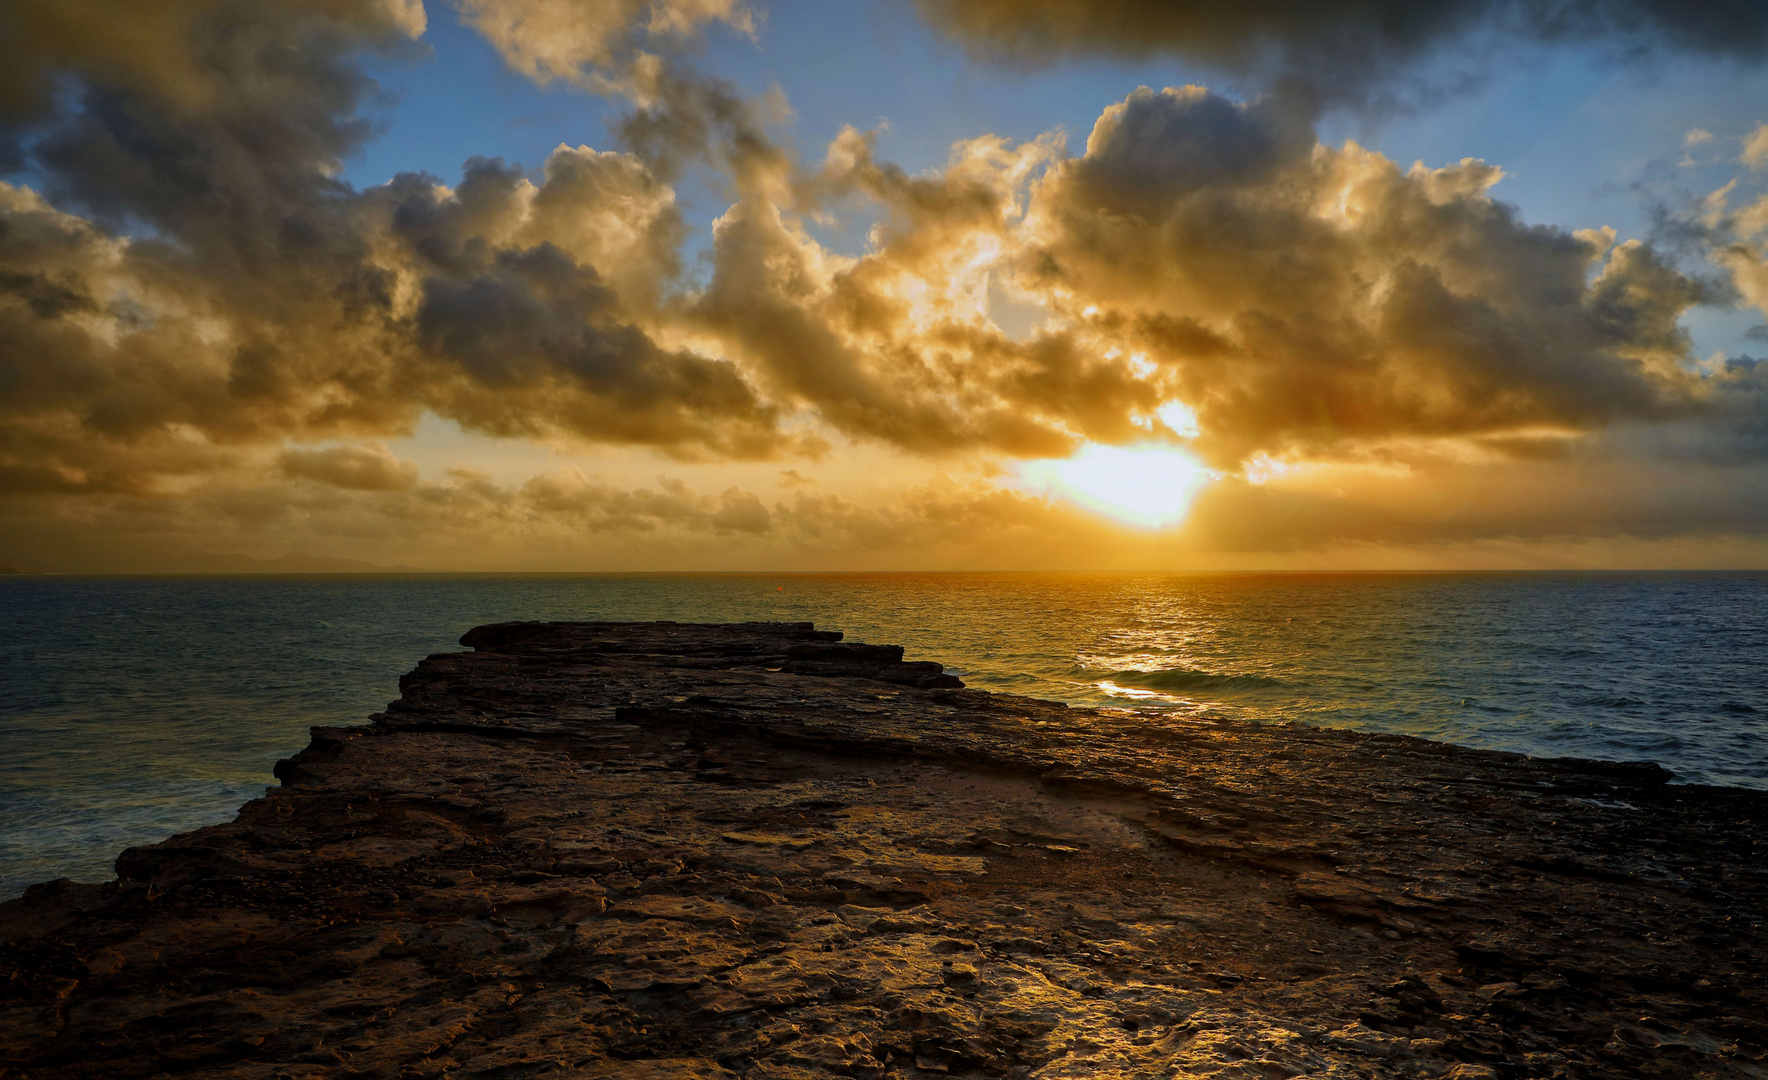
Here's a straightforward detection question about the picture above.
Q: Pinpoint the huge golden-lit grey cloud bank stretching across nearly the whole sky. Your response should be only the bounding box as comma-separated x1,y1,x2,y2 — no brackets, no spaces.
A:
0,5,1725,484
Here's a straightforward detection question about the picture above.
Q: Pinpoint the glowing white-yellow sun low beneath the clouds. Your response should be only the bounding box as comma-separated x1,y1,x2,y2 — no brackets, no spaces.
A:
1018,444,1215,529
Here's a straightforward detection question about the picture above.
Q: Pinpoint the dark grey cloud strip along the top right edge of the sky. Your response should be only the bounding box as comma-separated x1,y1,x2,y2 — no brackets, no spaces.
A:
918,0,1768,101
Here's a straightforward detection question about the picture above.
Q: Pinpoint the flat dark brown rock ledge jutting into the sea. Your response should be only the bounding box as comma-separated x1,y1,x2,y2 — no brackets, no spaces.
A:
0,622,1768,1080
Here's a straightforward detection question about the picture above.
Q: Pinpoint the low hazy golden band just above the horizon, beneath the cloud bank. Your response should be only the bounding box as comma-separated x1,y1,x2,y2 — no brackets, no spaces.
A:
17,447,1768,571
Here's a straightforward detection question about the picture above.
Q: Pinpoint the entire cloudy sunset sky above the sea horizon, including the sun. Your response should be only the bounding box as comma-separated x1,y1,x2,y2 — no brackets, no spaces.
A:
0,0,1768,573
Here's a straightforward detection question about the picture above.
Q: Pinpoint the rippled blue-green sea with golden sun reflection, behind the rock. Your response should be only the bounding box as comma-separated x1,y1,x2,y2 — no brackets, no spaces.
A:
0,573,1768,900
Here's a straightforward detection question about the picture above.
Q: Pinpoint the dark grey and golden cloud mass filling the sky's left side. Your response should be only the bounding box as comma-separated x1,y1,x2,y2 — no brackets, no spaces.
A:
0,0,812,488
